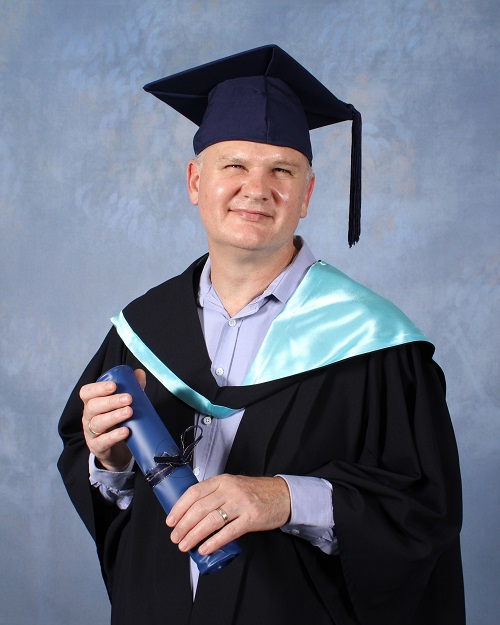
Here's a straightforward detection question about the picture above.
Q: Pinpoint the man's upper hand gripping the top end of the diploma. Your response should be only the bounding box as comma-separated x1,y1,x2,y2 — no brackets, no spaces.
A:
80,369,146,471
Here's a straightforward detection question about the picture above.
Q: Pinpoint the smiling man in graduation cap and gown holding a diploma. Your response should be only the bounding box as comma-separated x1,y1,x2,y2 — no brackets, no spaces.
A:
59,46,464,625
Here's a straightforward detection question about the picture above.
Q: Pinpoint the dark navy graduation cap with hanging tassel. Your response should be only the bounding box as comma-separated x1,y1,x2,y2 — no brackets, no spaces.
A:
144,45,361,246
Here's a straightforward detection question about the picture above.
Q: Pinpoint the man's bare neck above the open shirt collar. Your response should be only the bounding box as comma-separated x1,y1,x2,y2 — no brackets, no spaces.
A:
209,241,297,317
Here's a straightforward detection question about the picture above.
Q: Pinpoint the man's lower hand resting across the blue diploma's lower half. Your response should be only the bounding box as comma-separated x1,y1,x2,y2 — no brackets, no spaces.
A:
167,475,290,555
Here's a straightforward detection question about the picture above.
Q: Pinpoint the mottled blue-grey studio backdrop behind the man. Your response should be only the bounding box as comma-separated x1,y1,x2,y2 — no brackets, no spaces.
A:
0,0,500,625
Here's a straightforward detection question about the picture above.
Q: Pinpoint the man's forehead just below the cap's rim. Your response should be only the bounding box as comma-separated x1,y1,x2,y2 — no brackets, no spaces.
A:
202,141,309,168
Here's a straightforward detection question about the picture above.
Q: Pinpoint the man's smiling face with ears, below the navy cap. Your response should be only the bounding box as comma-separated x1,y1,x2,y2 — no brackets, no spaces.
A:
187,141,314,253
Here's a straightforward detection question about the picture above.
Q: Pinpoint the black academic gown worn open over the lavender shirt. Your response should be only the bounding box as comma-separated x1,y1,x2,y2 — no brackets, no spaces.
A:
59,255,465,625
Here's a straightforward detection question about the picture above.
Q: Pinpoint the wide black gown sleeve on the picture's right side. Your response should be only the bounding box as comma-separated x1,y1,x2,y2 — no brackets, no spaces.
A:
308,344,464,625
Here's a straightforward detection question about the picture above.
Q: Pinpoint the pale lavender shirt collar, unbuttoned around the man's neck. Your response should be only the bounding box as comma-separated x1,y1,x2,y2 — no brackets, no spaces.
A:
198,236,316,308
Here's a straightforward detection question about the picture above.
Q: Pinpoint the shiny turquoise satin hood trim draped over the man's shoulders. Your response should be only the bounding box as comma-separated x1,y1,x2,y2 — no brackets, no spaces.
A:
111,261,428,419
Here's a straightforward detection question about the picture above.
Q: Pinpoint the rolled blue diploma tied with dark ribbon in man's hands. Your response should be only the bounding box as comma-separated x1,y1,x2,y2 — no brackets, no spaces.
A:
97,365,241,575
